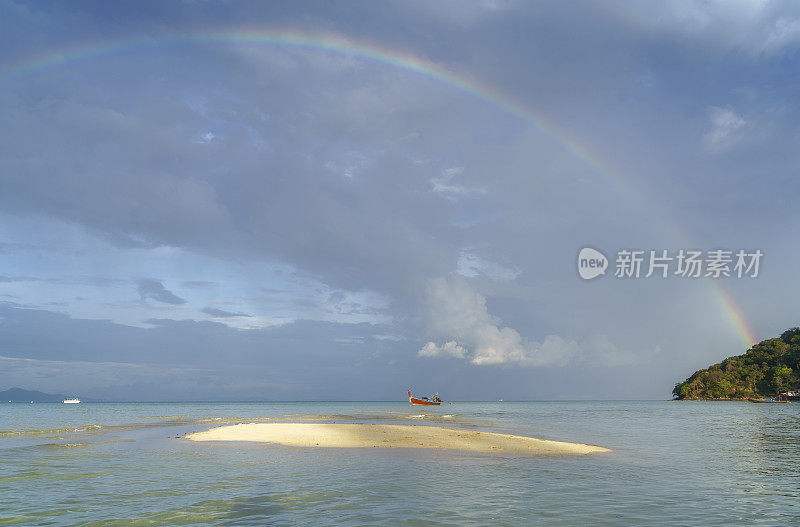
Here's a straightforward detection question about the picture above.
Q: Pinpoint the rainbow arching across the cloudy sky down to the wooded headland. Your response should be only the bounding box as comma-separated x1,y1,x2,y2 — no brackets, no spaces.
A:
0,29,757,347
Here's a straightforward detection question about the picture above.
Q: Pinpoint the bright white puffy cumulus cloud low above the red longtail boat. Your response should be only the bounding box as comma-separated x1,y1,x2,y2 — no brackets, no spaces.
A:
417,277,579,366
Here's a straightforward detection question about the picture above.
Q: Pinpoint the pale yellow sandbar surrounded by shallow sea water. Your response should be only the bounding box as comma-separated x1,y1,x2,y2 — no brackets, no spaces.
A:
186,423,610,455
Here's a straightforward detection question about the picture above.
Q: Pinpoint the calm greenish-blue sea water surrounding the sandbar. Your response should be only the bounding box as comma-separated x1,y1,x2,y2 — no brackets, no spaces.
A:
0,401,800,525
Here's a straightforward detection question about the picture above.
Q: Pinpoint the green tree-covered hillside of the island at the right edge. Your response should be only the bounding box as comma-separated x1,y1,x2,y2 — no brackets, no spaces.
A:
672,328,800,399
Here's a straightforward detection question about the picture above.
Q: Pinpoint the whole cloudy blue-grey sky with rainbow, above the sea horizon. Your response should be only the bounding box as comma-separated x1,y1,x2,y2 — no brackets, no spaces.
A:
0,0,800,400
